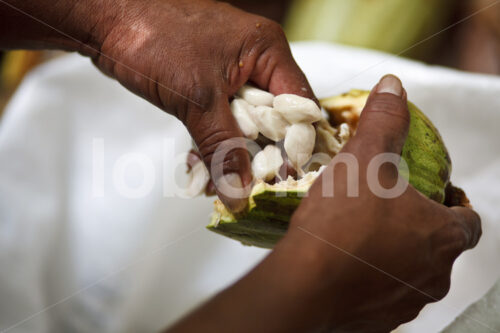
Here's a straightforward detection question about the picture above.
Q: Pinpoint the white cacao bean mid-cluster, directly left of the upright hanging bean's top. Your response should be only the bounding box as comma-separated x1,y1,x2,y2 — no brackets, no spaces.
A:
250,105,289,142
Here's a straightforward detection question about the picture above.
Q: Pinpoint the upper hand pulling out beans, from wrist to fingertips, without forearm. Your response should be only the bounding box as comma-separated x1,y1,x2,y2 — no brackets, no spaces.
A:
87,0,314,211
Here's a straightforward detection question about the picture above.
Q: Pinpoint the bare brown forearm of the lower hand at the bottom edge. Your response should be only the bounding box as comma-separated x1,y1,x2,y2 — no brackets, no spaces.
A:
168,236,342,333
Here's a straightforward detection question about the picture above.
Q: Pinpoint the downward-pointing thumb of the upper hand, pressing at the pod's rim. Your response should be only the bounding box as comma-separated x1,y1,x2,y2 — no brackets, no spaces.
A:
185,96,252,212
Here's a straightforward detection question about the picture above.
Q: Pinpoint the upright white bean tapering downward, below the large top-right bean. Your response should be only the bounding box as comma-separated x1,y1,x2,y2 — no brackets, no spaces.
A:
285,123,316,174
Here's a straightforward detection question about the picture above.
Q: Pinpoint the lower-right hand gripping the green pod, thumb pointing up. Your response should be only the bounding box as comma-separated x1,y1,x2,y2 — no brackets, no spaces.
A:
275,76,481,332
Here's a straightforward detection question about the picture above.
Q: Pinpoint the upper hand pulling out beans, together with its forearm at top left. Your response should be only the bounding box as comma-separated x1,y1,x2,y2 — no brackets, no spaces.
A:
0,0,314,212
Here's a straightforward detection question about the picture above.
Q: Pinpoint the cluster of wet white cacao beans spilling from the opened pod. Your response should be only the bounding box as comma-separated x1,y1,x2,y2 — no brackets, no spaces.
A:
184,85,351,195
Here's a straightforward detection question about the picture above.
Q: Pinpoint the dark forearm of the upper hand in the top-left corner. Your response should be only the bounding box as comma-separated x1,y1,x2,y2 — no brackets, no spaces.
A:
0,0,118,55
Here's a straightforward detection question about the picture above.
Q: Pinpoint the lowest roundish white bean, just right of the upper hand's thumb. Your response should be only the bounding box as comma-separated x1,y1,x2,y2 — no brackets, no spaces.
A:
252,145,283,181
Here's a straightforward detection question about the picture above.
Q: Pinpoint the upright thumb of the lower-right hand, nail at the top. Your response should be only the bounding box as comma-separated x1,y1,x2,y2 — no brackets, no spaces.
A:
351,75,410,157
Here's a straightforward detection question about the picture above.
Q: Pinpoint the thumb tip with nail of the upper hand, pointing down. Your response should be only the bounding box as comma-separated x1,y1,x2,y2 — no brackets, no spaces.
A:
216,173,250,213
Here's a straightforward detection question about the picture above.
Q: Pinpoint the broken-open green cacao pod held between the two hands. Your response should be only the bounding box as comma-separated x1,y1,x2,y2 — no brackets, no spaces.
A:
207,90,451,248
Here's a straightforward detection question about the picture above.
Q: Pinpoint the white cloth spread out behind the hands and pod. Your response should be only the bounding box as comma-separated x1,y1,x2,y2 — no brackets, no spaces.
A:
0,43,500,332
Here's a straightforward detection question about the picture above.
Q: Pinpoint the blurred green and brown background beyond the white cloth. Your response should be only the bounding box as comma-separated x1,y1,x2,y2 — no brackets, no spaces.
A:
0,0,500,114
